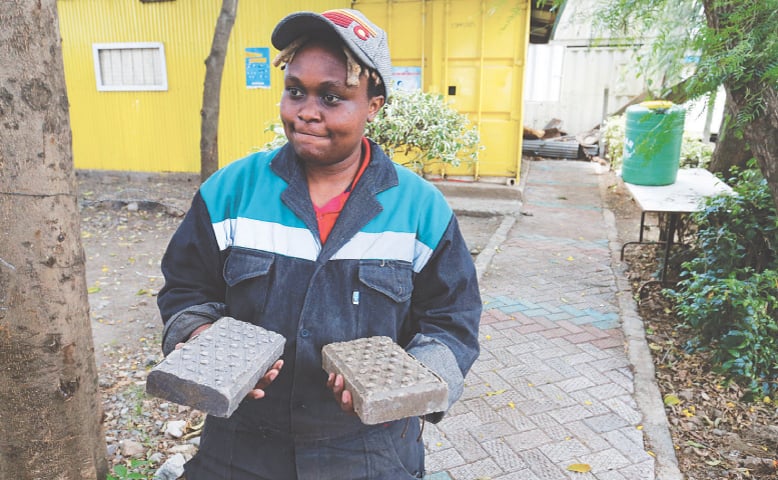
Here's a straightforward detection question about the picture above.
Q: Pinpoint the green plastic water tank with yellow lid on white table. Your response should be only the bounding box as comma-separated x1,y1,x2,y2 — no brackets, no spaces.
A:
621,101,686,185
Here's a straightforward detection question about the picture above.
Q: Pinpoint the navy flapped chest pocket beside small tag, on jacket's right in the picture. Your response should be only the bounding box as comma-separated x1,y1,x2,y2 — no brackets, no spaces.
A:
352,260,413,339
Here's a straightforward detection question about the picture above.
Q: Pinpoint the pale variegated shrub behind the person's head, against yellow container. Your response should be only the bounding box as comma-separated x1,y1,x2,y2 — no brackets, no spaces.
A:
259,91,483,172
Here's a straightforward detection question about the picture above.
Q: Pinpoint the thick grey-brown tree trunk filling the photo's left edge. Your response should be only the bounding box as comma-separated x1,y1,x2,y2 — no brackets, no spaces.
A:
0,0,108,480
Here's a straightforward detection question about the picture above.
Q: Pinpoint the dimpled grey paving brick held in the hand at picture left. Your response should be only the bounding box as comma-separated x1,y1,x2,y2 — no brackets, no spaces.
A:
146,317,286,417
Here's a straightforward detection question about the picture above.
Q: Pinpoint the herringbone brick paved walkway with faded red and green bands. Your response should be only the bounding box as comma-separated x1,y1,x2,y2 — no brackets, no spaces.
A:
424,160,655,480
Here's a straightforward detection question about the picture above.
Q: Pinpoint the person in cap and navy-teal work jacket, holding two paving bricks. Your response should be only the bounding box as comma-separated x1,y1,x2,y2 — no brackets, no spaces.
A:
158,10,481,480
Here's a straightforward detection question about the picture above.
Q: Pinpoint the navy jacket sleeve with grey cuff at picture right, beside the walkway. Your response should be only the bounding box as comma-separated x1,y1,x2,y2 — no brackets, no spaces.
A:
406,215,483,422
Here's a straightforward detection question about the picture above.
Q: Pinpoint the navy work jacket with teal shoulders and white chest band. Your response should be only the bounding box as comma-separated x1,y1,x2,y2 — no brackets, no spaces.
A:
158,142,482,440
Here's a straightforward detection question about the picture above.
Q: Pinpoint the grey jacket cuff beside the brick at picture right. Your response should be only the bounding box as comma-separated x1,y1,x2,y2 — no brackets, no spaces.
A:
405,333,465,423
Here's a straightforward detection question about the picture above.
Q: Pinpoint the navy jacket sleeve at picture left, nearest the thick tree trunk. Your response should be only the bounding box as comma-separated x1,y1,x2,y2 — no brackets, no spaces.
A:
157,192,228,355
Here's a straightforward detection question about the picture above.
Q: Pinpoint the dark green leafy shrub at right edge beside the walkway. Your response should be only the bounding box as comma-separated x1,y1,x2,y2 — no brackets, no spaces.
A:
668,169,778,397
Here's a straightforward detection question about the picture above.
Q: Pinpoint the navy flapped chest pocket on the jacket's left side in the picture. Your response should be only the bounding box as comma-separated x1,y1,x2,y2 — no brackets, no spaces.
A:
223,248,275,321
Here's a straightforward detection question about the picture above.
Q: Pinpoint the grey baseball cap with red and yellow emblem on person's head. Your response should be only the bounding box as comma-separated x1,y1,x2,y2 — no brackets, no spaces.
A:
270,9,392,96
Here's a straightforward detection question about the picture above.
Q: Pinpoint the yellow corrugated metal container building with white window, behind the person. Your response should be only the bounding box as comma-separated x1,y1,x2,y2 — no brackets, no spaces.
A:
57,0,529,181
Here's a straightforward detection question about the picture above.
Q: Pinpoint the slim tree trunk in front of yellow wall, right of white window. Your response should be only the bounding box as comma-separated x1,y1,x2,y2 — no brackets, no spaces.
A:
200,0,238,182
